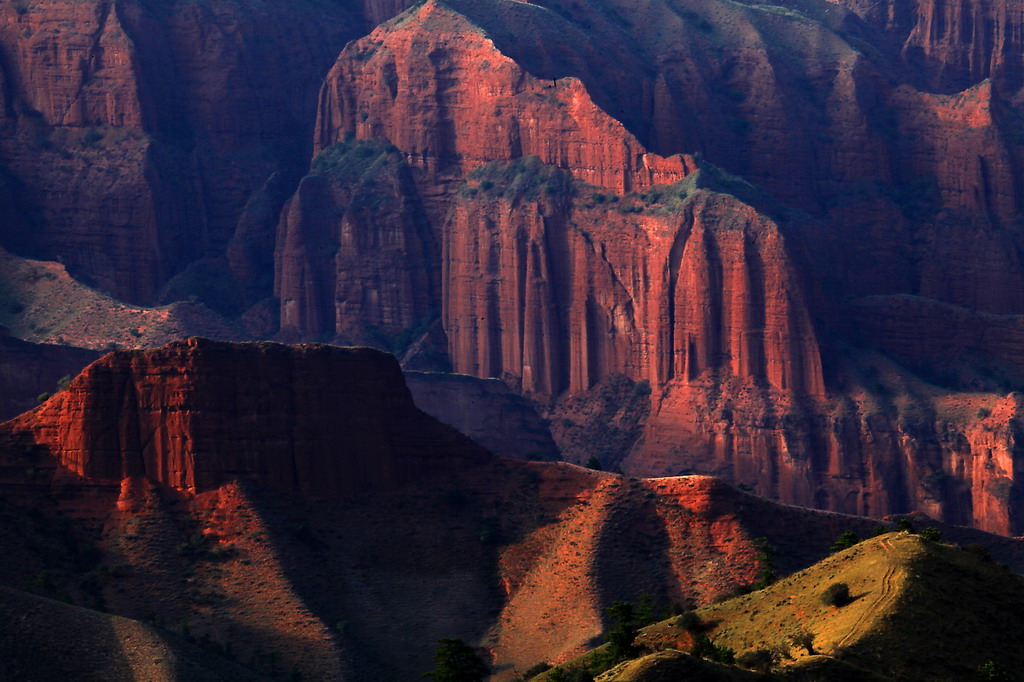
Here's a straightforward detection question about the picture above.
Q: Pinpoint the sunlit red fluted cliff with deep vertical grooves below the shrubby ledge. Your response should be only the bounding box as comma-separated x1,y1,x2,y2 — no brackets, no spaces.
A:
442,165,823,396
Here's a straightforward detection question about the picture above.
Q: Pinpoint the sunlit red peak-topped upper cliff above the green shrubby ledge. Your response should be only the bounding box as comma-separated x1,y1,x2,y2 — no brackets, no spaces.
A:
315,1,692,193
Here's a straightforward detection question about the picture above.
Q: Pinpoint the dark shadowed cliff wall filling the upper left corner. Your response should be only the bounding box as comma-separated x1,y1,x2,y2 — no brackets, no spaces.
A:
0,0,378,303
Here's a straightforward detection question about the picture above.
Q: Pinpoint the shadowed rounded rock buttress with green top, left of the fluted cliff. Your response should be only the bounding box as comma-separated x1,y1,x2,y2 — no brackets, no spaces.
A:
275,142,438,342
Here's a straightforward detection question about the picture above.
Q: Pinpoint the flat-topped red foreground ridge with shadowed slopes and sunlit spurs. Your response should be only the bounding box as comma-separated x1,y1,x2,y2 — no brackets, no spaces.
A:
0,339,1024,680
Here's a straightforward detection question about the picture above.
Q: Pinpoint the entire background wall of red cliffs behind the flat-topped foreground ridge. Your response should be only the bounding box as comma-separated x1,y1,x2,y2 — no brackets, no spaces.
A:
6,0,1024,532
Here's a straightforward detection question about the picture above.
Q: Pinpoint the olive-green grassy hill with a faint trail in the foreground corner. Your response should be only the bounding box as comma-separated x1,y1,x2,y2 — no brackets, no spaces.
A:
552,534,1024,682
